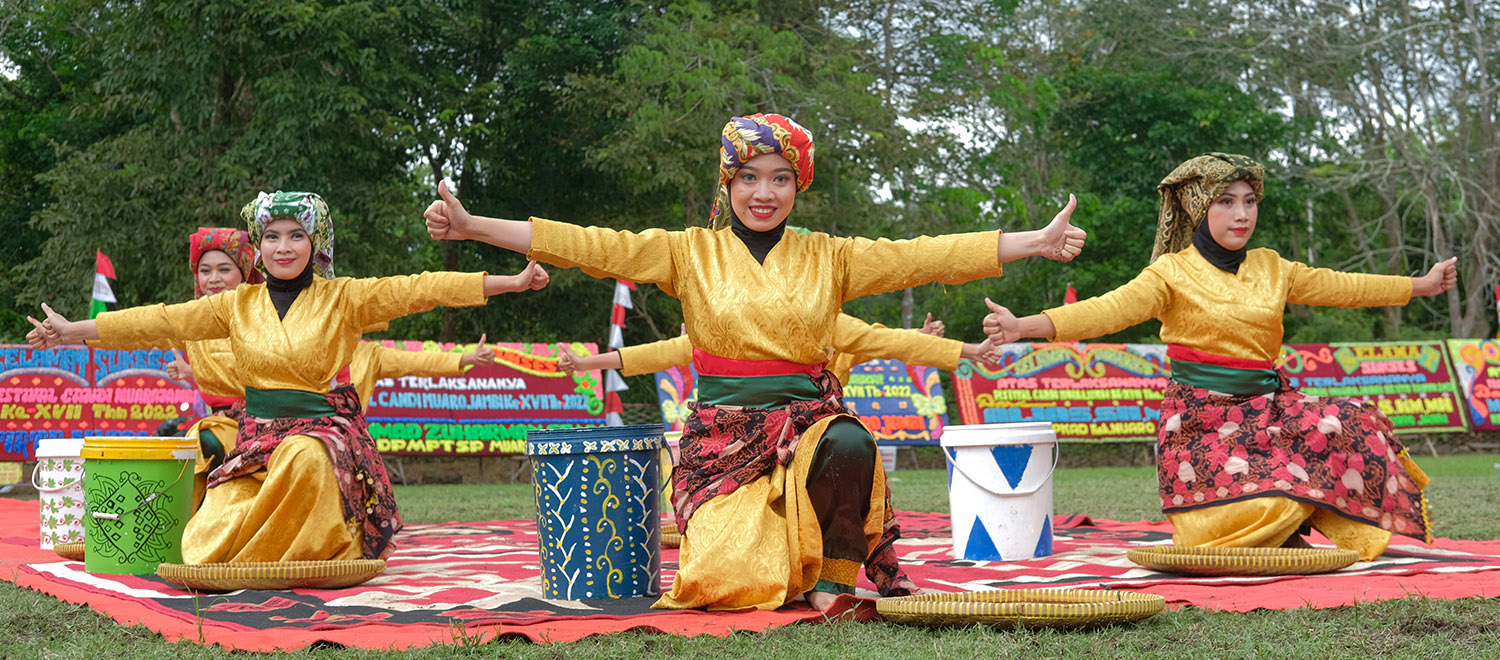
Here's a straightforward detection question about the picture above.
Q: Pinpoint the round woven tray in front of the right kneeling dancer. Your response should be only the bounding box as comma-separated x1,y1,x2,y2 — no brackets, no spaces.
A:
1125,546,1359,576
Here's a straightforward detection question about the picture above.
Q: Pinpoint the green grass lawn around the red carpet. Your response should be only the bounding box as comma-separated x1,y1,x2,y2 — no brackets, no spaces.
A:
0,456,1500,660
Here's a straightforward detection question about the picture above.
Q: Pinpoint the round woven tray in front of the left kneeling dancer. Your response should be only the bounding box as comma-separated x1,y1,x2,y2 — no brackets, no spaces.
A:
156,560,386,591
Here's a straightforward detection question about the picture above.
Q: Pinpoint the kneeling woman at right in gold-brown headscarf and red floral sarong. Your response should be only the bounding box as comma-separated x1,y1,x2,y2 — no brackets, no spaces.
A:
986,153,1457,560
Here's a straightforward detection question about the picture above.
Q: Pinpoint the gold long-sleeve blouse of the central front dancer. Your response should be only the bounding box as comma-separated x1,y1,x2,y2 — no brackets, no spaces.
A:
527,218,1001,365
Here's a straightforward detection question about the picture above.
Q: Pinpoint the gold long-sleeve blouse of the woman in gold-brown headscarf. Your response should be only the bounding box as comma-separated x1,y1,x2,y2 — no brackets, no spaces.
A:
1043,248,1412,362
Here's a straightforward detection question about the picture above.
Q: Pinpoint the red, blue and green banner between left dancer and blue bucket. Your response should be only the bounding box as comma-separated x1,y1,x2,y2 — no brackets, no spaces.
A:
365,341,605,456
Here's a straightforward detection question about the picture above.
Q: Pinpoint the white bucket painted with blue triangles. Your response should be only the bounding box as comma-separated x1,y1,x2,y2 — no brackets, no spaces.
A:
942,422,1058,561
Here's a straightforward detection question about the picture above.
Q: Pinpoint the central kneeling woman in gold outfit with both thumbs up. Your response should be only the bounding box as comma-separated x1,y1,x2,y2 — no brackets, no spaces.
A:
426,114,1085,609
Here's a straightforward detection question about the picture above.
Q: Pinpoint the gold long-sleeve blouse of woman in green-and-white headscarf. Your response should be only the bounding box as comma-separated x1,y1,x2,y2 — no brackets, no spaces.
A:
98,273,486,393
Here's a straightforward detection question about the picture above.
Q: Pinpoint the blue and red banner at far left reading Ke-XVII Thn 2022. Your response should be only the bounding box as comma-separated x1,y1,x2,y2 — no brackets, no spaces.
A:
0,345,195,462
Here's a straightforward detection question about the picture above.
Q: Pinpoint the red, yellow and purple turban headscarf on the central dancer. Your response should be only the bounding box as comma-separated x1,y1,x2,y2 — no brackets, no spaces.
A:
708,114,813,228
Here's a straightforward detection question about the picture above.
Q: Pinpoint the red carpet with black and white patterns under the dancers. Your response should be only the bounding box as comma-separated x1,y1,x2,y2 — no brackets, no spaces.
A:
0,500,1500,651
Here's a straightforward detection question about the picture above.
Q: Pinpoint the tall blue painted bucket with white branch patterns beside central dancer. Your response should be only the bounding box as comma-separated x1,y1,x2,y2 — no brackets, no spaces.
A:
527,425,666,600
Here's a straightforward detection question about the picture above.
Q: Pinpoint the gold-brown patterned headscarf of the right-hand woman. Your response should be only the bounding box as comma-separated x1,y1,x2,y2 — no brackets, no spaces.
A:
1151,152,1266,261
